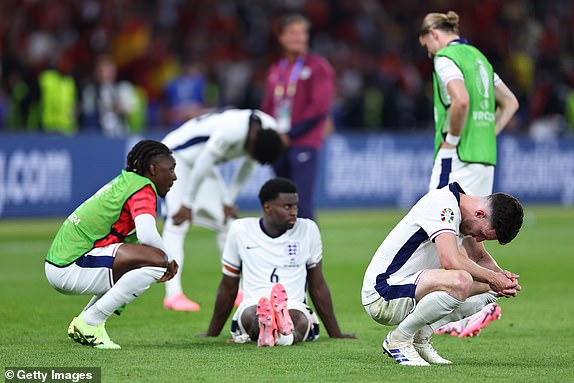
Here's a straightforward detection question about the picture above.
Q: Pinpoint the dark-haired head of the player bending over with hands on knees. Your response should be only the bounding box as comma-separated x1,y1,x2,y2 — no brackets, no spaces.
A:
249,113,283,164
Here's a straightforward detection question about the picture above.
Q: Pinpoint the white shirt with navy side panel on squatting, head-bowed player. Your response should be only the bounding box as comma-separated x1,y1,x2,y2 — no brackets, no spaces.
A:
361,183,464,305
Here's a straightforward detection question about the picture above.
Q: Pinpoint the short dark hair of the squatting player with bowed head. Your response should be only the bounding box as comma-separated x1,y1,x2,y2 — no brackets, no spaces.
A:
487,193,524,245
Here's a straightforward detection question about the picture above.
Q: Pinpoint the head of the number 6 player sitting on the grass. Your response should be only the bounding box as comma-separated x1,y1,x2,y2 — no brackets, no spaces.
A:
259,177,299,233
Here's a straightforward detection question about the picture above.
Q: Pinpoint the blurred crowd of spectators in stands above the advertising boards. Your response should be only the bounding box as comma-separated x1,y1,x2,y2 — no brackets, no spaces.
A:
0,0,574,135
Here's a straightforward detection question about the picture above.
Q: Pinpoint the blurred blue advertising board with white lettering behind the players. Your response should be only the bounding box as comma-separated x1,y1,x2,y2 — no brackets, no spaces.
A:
0,134,574,219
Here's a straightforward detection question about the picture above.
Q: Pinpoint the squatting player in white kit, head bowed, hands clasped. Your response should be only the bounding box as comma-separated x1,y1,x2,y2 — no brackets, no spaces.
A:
362,183,524,366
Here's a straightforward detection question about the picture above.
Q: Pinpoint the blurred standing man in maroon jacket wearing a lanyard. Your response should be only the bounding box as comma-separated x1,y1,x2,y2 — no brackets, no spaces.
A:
261,14,335,219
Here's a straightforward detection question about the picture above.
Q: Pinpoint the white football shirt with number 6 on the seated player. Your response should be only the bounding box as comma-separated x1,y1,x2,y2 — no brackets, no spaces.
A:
222,218,323,303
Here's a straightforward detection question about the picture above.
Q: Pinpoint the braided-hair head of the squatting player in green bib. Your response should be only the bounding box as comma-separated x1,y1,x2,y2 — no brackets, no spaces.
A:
126,140,177,197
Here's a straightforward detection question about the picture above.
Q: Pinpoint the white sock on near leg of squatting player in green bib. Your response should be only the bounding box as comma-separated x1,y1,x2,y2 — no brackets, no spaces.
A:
84,266,166,326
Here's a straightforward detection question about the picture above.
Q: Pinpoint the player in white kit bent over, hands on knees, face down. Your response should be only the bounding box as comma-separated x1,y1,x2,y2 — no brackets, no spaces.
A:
163,109,283,311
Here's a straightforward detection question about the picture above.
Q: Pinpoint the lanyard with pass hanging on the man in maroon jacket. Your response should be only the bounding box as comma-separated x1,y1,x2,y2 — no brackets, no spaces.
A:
274,57,305,132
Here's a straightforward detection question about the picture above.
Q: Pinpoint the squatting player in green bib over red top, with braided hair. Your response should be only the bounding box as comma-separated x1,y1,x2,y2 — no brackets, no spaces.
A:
45,140,178,349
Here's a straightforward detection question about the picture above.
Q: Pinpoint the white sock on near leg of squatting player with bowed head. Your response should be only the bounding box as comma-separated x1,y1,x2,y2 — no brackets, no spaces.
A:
392,291,462,341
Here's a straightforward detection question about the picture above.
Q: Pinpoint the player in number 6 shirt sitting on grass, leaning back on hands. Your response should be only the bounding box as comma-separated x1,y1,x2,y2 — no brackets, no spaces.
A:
204,178,355,347
